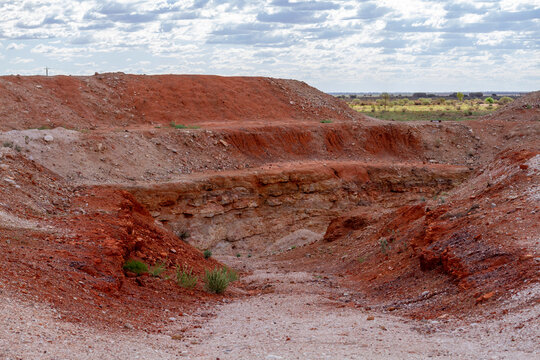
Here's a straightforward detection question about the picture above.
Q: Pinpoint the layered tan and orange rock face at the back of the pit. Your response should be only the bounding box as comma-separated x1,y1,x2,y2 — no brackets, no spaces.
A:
127,161,469,253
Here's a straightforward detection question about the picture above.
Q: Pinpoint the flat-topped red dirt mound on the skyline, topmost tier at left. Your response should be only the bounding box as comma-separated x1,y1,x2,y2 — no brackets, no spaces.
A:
0,73,362,130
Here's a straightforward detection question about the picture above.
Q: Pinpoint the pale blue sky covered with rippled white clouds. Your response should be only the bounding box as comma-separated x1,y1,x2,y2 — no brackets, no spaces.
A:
0,0,540,91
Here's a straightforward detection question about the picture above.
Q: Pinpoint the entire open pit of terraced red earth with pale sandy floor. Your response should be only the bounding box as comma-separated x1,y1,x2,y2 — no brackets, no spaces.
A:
0,73,540,359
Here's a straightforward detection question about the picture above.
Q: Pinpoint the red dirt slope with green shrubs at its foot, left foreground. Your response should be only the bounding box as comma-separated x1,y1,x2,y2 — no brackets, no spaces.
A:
0,151,224,327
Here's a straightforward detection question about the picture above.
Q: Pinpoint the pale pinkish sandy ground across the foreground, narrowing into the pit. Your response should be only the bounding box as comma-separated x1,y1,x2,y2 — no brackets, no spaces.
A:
0,258,540,360
